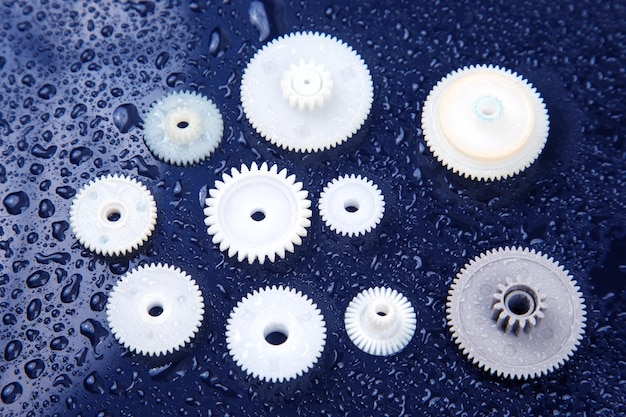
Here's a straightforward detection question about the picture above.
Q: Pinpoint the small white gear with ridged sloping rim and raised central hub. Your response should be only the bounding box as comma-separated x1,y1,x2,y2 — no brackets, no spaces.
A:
344,287,417,356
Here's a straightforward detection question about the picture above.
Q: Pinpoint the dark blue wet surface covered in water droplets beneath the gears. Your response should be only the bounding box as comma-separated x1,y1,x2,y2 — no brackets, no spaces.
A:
0,0,626,416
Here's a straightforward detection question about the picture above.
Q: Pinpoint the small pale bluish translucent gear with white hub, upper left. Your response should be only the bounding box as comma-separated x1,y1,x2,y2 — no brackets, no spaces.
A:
144,91,224,166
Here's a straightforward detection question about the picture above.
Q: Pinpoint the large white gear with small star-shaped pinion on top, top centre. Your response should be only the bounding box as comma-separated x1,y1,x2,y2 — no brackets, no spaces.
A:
241,32,374,152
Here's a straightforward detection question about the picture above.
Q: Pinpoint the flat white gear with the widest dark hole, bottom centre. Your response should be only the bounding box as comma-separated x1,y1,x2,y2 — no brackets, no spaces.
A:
226,285,326,382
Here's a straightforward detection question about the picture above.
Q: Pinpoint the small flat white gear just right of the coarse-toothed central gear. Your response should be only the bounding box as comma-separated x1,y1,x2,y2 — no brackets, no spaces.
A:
318,174,385,237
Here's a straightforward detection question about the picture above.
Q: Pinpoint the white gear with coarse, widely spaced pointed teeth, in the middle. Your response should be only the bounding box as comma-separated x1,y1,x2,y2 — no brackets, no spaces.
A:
204,163,311,264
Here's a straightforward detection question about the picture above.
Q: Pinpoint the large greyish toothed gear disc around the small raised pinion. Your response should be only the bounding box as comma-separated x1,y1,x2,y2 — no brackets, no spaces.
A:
447,247,586,379
